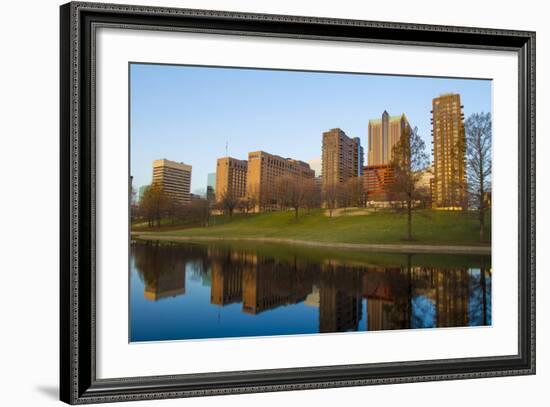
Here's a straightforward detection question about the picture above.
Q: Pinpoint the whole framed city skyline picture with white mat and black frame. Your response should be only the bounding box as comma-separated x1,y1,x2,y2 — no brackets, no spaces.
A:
60,2,535,404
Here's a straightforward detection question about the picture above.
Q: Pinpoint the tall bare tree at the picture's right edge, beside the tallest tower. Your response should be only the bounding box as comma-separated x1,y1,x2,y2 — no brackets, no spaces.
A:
464,113,492,241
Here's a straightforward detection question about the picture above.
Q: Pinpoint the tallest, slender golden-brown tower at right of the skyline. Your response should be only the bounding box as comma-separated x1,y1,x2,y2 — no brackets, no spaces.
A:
431,93,466,208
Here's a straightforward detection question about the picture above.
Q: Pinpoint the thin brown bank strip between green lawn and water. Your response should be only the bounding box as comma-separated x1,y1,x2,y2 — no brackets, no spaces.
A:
130,232,491,255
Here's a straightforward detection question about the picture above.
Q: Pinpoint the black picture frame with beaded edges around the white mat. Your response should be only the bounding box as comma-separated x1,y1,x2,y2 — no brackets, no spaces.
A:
60,2,535,404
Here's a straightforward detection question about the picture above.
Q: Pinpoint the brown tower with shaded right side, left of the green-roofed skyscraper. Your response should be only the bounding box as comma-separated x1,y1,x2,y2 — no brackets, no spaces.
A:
321,128,364,187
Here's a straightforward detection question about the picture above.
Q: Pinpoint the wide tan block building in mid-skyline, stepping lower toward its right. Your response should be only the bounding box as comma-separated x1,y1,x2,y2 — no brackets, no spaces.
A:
246,151,315,210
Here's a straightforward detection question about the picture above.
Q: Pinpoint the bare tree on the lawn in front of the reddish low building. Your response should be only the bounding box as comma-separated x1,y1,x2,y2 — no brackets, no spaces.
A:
389,126,429,240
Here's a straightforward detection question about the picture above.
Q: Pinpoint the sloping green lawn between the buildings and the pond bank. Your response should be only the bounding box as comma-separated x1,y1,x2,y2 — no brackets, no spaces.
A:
133,209,491,245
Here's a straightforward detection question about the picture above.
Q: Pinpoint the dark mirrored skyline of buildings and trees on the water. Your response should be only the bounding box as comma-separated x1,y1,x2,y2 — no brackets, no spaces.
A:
132,242,491,332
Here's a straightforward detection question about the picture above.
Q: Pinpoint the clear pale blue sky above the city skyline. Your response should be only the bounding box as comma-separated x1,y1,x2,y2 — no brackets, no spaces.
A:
130,64,492,192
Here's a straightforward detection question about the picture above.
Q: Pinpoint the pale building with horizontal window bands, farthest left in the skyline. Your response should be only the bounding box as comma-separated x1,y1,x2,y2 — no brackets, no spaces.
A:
152,159,191,204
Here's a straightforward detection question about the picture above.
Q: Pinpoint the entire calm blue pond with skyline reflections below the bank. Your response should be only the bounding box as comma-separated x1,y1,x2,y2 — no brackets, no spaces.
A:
130,242,491,342
